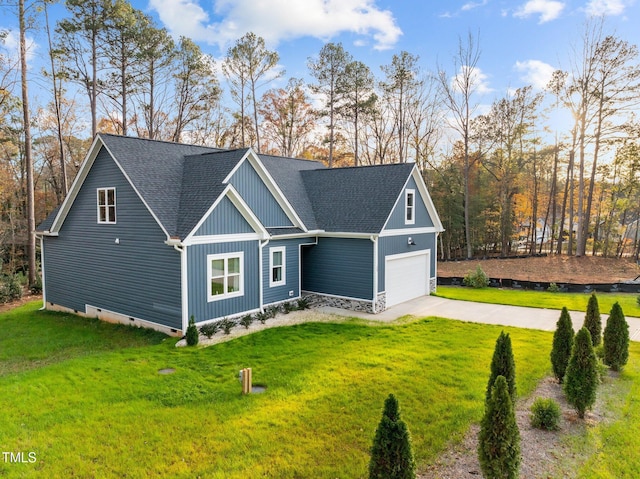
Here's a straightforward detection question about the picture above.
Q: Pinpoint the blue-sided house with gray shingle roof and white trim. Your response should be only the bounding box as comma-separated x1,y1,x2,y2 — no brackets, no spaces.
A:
37,134,443,335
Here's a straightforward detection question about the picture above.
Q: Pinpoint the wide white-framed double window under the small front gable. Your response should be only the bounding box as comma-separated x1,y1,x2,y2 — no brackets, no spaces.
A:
207,251,244,301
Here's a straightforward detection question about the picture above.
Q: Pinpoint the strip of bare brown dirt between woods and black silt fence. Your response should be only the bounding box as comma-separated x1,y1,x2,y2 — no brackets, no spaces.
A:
438,256,640,284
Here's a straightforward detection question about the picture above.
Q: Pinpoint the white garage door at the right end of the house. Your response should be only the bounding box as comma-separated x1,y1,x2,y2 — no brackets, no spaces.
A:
385,250,431,308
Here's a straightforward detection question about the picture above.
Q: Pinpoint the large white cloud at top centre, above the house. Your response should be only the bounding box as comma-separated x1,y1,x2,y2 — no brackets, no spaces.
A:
150,0,402,50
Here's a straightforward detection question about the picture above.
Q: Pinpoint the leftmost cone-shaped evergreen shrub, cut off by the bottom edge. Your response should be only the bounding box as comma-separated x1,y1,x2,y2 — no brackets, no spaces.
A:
369,394,416,479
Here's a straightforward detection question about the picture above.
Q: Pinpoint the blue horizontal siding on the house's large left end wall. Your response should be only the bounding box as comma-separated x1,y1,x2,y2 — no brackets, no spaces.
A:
43,148,182,329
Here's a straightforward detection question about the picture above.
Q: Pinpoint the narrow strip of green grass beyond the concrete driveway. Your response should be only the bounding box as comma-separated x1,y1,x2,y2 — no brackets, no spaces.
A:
435,286,640,317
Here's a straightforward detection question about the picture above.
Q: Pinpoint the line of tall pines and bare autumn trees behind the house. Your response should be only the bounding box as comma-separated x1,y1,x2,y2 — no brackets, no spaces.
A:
0,0,640,280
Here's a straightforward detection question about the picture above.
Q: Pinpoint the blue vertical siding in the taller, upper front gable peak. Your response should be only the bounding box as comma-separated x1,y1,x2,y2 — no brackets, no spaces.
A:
230,161,293,228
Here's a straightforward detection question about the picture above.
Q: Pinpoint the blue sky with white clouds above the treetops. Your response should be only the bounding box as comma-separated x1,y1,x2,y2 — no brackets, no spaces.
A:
0,0,640,117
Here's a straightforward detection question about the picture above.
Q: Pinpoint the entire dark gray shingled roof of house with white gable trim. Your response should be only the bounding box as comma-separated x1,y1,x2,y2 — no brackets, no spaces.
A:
38,134,439,239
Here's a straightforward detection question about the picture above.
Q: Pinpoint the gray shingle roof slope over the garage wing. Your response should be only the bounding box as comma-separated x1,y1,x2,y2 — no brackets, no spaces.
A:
302,163,414,233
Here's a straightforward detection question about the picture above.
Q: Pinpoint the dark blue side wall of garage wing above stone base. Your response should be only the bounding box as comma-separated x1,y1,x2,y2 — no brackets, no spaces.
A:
302,238,374,300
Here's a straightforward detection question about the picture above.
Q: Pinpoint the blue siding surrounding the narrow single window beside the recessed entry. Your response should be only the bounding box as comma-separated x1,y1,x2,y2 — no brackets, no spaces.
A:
262,237,316,304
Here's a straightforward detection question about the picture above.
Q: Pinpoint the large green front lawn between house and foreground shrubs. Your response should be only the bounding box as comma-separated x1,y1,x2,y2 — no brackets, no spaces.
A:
0,306,551,478
